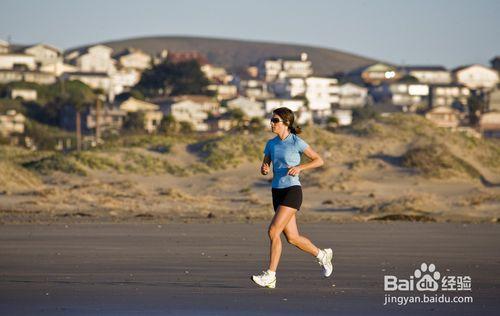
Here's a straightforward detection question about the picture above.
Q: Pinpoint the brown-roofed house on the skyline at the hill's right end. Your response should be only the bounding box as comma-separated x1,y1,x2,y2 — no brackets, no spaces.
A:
345,63,403,86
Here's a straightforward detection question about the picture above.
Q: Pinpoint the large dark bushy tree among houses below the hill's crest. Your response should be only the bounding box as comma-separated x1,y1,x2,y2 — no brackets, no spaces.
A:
134,60,210,97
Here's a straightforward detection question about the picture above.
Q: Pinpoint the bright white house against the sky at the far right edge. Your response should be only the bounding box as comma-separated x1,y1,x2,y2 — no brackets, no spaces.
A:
453,64,499,91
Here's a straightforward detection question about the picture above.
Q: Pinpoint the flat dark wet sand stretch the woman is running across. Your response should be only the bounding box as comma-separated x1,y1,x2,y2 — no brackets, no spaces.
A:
0,222,500,315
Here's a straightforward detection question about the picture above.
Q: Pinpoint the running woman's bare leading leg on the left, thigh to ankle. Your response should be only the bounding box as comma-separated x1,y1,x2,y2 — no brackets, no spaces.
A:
268,205,297,272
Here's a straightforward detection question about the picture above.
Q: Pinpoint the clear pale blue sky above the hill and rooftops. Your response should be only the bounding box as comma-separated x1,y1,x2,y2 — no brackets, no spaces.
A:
0,0,500,67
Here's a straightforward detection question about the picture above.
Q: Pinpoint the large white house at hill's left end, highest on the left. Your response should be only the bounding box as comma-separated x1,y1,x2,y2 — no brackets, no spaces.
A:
66,44,116,74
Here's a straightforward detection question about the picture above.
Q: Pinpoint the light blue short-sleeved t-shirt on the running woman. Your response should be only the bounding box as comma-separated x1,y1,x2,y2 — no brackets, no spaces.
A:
264,133,309,189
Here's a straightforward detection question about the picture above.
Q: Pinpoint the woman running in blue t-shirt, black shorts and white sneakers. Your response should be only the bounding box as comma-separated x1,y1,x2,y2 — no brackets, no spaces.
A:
252,107,333,288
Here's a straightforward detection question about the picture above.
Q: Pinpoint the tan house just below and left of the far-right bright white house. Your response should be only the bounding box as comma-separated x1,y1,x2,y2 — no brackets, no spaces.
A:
429,84,470,107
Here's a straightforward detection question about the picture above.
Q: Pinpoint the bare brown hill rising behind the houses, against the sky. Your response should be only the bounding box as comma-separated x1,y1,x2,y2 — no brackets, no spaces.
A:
68,36,376,75
